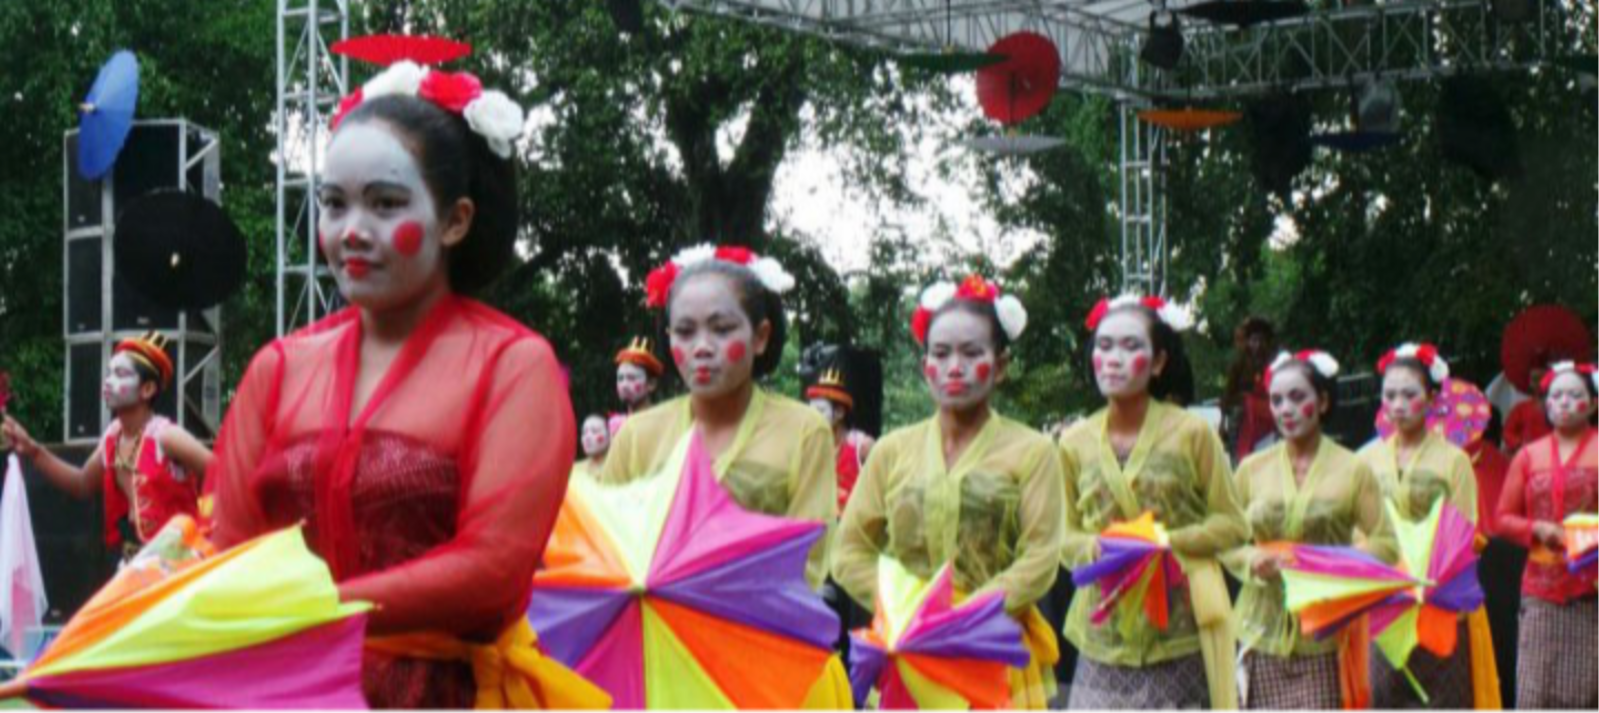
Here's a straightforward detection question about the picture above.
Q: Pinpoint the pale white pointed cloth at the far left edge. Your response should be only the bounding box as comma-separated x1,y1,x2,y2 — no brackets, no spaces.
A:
0,456,50,659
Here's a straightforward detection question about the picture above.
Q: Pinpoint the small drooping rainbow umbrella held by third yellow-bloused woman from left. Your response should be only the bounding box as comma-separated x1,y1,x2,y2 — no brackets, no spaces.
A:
1071,512,1183,631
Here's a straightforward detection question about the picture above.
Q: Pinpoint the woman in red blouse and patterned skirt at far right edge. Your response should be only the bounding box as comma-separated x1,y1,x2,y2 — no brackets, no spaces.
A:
1498,361,1599,713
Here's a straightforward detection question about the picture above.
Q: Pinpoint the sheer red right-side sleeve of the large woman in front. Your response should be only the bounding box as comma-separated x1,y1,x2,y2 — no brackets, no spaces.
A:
339,337,576,636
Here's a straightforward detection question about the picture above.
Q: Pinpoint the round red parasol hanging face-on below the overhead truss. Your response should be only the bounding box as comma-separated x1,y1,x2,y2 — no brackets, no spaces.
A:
977,32,1060,126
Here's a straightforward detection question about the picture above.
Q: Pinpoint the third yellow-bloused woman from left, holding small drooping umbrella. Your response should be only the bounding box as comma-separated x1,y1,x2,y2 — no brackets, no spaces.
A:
1060,296,1249,713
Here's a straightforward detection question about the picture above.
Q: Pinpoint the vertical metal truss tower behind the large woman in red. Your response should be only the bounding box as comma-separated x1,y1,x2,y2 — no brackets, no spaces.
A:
273,0,350,336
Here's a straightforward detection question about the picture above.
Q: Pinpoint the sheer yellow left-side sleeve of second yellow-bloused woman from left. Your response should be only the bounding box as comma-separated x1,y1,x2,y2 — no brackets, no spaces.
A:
833,438,900,611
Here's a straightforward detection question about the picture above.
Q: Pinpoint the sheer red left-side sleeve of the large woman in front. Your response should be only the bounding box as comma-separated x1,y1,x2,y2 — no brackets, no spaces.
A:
205,342,285,548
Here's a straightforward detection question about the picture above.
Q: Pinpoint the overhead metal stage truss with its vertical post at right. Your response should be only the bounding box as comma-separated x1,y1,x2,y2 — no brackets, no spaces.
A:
660,0,1594,293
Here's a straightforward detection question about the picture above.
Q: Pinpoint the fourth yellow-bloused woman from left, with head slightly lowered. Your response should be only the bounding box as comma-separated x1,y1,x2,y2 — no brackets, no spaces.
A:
1222,350,1396,713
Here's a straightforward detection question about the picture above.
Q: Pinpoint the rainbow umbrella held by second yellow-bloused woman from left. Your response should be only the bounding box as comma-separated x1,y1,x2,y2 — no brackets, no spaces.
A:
849,556,1030,713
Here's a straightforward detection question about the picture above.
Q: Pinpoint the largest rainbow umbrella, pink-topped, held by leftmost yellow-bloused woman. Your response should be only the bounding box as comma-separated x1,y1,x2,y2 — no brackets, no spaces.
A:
528,433,839,713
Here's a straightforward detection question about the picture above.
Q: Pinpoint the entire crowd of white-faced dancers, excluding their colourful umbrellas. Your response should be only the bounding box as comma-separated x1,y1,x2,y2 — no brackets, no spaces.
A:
5,62,1599,713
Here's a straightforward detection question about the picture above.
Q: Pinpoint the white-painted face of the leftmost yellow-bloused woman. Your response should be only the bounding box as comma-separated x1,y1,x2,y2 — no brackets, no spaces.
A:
667,273,766,396
